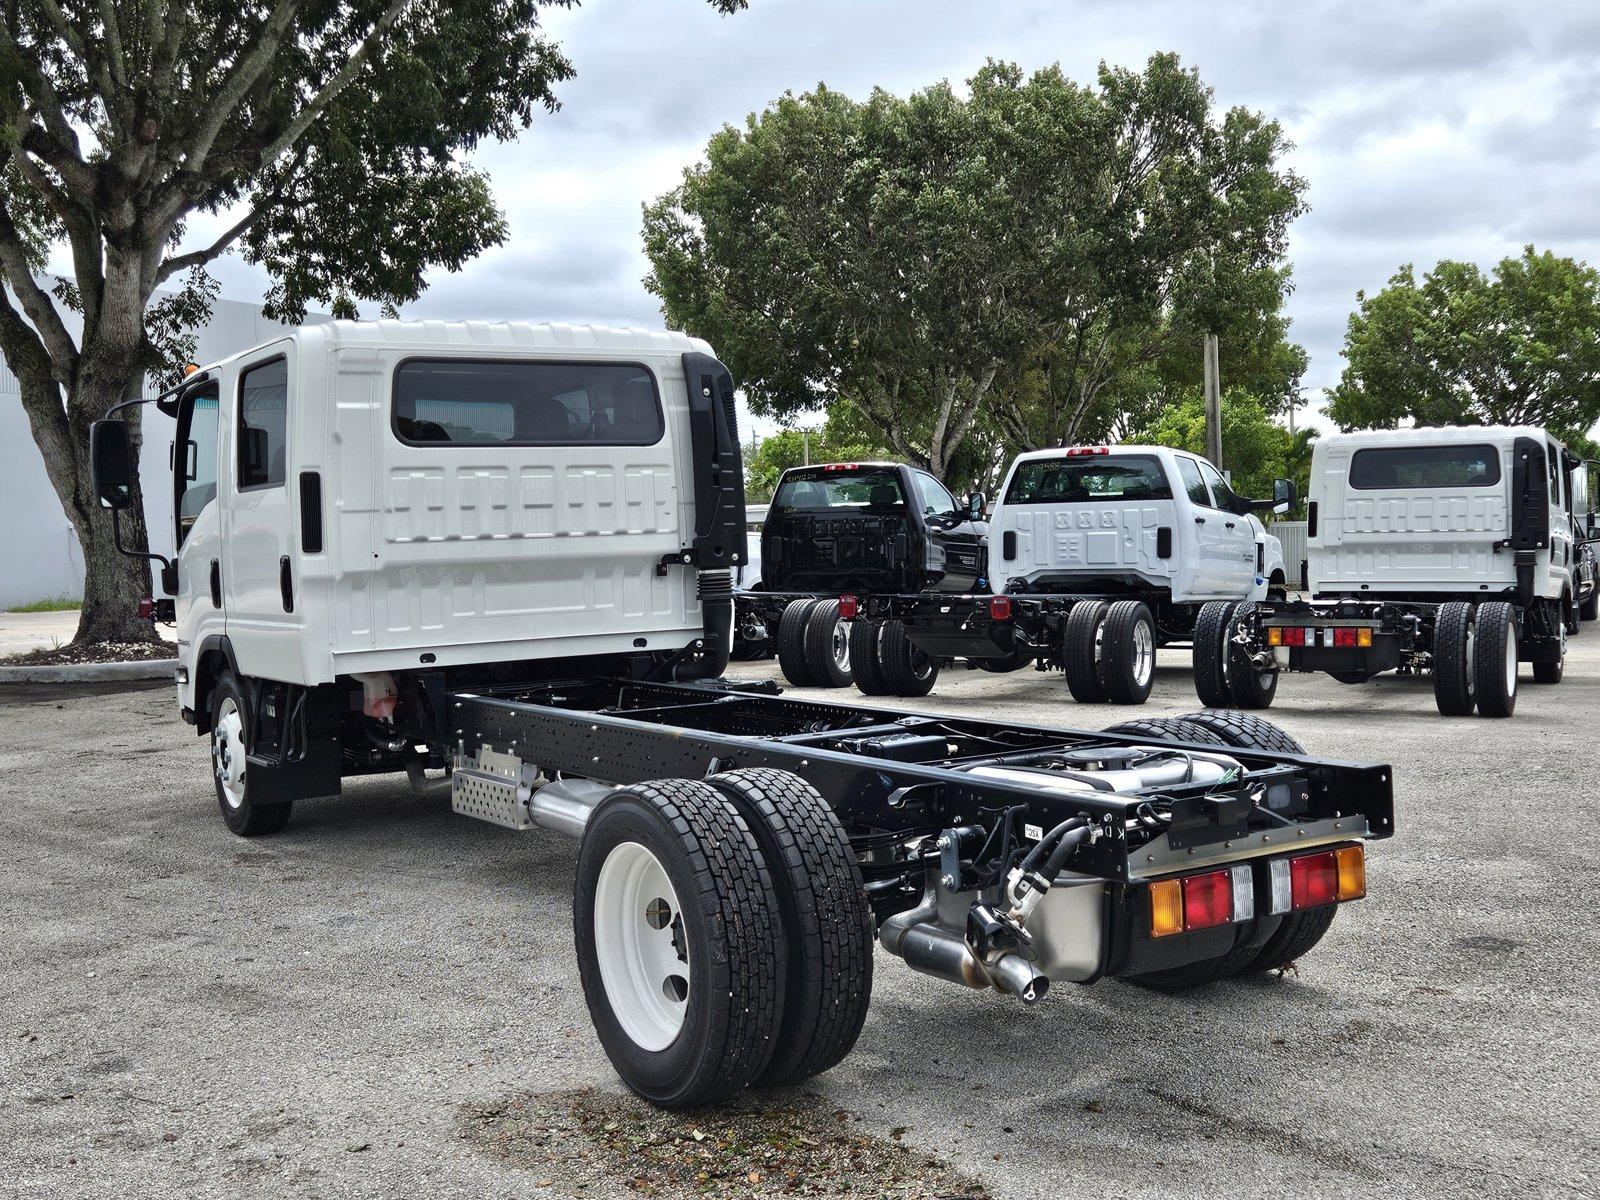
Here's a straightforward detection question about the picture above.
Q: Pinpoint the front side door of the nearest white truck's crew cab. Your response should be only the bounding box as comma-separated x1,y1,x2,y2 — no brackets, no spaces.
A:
173,382,227,684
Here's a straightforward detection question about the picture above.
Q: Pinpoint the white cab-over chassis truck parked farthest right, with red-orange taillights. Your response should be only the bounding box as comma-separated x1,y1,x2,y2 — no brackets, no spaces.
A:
1195,426,1595,717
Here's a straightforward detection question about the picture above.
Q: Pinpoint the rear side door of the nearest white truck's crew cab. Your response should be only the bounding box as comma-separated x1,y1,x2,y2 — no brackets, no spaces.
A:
222,352,301,683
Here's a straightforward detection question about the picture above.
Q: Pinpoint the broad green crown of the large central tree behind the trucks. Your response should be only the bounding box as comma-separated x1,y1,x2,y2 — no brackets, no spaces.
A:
645,54,1302,475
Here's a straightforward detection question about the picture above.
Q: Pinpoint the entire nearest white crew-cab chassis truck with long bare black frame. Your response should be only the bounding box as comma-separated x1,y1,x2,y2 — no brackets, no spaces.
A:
91,322,1394,1106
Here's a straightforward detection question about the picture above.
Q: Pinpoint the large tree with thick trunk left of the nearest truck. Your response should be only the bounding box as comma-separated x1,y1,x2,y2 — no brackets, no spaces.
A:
0,0,744,642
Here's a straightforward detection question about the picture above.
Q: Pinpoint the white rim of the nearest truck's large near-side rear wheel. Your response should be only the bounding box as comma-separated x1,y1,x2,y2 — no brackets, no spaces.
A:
595,842,690,1051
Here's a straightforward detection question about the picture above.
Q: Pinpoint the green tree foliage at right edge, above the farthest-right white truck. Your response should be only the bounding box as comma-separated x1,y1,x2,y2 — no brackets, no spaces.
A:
1328,246,1600,432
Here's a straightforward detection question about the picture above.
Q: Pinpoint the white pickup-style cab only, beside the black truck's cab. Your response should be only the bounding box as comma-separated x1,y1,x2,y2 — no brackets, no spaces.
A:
992,446,1286,605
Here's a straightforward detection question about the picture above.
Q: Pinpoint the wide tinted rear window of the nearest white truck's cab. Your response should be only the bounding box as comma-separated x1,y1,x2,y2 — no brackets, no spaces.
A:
394,358,666,446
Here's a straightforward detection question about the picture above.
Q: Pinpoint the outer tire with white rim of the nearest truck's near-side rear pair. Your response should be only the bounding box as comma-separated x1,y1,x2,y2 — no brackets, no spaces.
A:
573,779,787,1109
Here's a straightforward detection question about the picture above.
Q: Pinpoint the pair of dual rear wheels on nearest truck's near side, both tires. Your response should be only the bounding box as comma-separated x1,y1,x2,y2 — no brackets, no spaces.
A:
573,770,872,1107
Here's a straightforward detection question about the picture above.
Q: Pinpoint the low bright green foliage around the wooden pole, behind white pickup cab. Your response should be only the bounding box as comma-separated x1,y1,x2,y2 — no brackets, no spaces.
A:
1128,389,1317,502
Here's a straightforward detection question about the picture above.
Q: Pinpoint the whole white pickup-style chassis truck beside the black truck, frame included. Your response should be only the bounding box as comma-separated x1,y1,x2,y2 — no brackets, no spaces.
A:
845,445,1294,704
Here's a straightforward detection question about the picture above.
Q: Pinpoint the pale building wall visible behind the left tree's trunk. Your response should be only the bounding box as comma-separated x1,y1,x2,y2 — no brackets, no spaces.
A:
0,292,328,610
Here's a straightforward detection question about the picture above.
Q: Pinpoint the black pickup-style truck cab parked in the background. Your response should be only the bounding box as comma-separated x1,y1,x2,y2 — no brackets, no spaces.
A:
762,462,989,595
